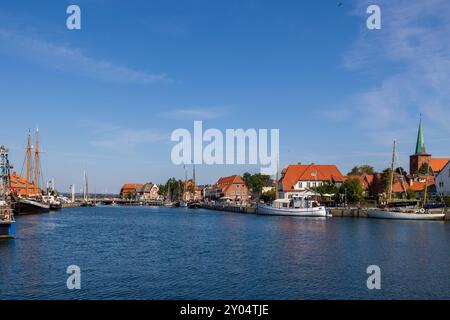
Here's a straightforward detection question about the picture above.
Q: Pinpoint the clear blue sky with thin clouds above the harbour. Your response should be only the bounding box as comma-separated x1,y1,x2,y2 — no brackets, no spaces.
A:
0,0,450,192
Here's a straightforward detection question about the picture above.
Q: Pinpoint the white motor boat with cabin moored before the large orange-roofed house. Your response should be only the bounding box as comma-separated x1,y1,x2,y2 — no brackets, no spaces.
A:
256,197,330,217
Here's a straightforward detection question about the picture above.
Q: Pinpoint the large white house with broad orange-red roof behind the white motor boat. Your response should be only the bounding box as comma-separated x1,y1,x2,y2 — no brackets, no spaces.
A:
278,164,344,199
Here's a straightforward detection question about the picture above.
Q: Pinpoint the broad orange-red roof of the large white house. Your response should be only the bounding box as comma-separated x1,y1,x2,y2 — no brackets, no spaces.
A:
281,164,344,190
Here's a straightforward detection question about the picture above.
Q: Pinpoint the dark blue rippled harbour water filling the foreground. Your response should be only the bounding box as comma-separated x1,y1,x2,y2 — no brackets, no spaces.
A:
0,207,450,299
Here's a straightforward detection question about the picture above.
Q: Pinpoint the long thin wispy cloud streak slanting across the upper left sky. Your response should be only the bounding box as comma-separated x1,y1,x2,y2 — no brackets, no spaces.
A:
0,28,171,84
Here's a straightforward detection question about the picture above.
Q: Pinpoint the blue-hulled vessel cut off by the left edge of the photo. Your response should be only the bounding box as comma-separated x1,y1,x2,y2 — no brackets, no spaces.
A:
0,146,16,239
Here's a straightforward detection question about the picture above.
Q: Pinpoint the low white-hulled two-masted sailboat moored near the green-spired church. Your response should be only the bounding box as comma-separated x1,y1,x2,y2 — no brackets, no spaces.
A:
367,140,445,220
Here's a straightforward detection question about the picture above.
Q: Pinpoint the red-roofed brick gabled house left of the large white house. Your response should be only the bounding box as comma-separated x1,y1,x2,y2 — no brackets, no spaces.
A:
205,175,248,203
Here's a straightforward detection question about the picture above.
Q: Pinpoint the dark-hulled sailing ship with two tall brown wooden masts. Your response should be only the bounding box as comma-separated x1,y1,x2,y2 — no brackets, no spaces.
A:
13,129,50,214
